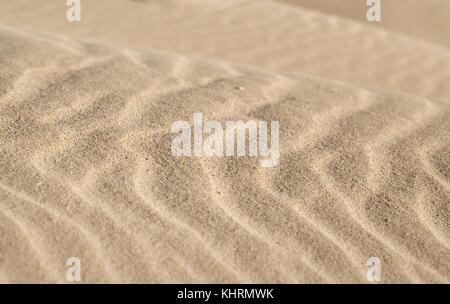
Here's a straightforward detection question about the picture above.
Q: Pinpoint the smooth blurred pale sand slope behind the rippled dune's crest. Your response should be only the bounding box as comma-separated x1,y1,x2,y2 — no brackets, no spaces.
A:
0,0,450,100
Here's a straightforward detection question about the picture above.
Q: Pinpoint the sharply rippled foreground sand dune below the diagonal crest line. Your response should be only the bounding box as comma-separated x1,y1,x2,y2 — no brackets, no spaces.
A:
0,23,450,283
